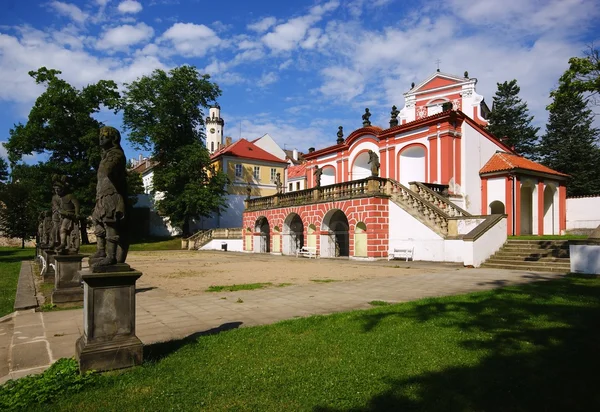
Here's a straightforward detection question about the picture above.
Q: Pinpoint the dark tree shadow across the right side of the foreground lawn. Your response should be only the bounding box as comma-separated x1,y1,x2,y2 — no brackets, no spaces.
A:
314,275,600,412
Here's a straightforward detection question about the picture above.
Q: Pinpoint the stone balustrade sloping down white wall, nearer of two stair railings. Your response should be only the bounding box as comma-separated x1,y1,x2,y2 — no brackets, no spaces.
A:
388,179,450,237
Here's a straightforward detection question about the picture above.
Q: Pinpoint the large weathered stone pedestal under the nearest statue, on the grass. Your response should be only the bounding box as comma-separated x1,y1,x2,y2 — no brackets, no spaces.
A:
76,263,143,373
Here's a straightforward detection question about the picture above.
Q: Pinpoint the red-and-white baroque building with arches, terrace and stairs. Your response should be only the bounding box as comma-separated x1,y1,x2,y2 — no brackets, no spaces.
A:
243,72,567,266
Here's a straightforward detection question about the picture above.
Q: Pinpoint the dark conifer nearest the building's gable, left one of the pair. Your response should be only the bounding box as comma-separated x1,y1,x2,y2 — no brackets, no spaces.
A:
487,80,539,159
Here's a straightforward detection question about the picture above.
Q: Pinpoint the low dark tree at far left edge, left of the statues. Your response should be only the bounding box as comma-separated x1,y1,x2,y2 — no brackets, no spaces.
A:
0,181,38,248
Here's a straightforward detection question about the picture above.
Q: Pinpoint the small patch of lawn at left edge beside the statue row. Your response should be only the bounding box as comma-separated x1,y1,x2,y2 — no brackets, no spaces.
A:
0,247,35,317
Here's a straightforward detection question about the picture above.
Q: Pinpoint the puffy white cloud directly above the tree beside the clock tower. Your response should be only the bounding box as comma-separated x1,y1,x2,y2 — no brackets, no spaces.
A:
161,23,221,57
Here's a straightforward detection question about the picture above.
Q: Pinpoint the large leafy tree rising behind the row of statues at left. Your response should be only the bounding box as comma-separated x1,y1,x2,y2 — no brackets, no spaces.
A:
5,67,120,243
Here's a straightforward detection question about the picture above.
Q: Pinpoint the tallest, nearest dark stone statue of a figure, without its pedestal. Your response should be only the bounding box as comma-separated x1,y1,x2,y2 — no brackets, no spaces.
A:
90,126,129,269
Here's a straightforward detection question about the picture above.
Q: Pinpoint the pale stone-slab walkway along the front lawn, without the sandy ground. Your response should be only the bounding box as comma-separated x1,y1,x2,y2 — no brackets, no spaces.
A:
0,268,563,384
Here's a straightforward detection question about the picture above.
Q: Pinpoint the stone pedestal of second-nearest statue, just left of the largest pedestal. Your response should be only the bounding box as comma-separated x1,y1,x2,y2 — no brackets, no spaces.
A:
52,254,85,304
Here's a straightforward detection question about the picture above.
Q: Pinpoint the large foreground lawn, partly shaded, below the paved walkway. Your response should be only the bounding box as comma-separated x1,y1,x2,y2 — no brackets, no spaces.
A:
9,276,600,412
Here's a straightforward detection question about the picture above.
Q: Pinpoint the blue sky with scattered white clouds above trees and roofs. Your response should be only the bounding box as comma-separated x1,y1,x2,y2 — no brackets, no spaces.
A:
0,0,600,162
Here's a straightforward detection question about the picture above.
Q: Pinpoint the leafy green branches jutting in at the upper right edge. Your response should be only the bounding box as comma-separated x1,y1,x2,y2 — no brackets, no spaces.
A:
549,46,600,107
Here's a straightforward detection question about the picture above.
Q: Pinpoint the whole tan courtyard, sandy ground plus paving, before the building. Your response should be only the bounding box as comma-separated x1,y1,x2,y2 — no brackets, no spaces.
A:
0,252,563,383
